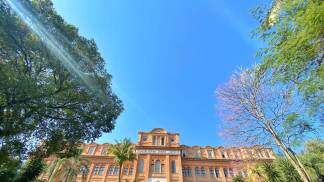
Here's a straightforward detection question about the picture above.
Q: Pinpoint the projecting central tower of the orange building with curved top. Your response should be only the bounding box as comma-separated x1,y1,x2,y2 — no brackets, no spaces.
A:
136,128,183,182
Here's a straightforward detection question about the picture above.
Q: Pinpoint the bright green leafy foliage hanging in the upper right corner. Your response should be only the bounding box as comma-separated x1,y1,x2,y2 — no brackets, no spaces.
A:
254,0,324,114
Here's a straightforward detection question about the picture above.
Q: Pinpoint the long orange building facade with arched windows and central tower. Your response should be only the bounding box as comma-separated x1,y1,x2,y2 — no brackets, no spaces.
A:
43,128,275,182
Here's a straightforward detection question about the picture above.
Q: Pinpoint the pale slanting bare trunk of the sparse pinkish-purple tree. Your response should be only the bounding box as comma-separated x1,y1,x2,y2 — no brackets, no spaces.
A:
267,125,311,182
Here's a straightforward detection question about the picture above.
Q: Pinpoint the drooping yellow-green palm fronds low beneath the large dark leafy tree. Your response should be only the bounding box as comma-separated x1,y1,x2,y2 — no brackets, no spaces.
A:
47,156,89,182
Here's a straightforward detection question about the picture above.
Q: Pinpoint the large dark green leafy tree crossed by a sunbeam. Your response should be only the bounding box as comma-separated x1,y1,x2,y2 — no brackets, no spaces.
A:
0,0,123,168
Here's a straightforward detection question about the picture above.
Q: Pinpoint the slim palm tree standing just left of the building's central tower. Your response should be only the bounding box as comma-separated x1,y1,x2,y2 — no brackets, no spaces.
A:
109,139,136,182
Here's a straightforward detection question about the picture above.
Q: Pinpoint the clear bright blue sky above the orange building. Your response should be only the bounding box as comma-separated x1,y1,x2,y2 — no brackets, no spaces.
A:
53,0,268,146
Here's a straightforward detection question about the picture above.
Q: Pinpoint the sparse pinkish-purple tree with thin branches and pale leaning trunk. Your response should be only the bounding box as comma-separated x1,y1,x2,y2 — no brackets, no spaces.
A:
216,65,313,181
